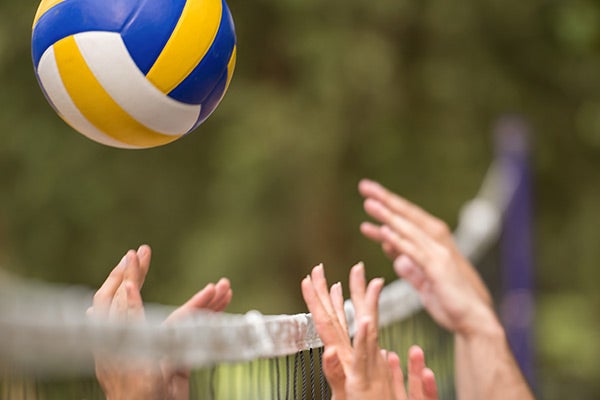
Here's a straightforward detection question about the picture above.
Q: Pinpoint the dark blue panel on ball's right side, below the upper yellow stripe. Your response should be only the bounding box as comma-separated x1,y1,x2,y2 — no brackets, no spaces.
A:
169,1,235,104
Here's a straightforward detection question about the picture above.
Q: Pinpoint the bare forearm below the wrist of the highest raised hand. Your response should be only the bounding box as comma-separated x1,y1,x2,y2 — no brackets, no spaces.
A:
454,318,534,400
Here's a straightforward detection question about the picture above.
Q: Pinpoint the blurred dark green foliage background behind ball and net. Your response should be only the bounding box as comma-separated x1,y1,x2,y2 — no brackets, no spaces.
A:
0,0,600,399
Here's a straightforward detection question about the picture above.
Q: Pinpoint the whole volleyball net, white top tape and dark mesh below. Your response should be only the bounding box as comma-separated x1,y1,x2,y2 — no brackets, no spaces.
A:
0,123,521,400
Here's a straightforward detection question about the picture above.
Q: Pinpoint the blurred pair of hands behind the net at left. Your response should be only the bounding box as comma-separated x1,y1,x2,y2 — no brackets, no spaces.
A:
88,245,232,400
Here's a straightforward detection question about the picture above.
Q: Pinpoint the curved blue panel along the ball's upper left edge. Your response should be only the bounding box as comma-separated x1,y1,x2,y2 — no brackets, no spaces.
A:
31,0,140,68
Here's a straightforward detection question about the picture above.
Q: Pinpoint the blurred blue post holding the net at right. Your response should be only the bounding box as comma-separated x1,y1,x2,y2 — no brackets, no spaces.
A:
495,117,535,387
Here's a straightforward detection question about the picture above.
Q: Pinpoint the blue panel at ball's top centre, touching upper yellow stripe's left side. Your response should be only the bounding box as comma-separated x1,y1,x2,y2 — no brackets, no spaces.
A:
122,0,186,75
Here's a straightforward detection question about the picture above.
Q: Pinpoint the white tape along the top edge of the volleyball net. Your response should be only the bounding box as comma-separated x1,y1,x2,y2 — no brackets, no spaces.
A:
0,161,518,375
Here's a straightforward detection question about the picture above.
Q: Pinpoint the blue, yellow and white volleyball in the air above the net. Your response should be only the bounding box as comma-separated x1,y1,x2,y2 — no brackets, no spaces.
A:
31,0,236,149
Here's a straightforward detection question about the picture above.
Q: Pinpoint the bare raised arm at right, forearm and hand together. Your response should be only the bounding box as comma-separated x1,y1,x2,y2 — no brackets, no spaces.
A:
359,180,533,400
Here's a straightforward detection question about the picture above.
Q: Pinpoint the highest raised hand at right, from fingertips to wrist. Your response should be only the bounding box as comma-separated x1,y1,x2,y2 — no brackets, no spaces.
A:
359,180,499,337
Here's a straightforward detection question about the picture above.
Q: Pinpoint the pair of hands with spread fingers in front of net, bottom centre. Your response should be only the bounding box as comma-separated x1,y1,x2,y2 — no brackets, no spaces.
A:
301,264,438,400
